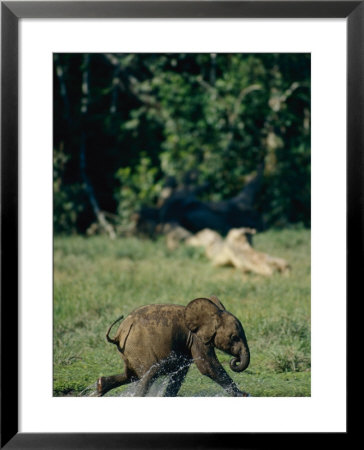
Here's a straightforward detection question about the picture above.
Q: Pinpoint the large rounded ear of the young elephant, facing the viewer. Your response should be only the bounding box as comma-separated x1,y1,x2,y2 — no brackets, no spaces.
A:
185,298,222,344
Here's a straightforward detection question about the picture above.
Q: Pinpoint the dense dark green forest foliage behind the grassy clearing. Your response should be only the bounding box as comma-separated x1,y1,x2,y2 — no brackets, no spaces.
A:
54,53,310,232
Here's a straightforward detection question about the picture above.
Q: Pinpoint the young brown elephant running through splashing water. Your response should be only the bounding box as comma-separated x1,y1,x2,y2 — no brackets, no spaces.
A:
97,296,250,397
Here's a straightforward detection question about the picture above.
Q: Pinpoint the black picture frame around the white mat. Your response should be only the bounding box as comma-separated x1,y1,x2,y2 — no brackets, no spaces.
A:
1,0,356,449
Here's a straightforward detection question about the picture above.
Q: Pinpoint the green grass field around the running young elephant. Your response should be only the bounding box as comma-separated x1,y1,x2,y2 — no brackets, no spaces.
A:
53,229,311,397
